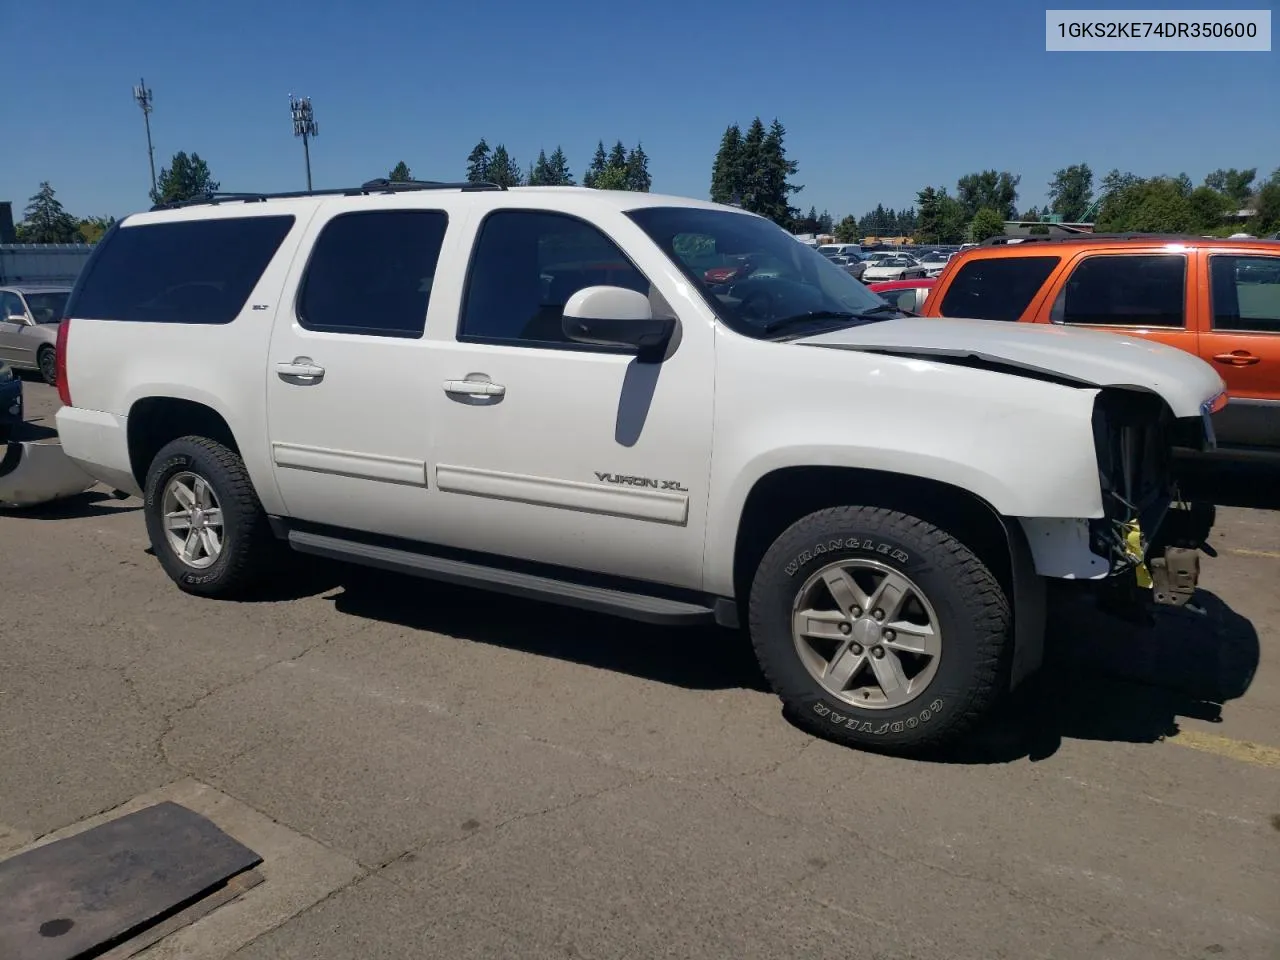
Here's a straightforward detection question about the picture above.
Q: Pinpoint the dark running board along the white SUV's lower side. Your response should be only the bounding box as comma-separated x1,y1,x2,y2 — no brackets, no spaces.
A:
288,530,721,626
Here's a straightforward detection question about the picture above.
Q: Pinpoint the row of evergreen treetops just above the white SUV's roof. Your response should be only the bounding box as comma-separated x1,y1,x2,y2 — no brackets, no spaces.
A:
458,140,653,193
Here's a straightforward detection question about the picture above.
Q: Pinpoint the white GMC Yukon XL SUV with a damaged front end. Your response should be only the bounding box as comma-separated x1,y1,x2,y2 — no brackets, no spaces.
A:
58,180,1222,753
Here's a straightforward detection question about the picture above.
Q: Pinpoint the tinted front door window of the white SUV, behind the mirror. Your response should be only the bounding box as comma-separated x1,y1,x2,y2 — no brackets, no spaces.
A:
458,210,649,351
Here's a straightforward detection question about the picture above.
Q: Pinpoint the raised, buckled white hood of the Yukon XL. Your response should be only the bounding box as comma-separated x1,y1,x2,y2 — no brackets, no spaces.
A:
795,317,1225,417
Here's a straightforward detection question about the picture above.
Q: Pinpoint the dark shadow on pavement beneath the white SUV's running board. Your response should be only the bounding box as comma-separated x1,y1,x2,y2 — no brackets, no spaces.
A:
334,568,768,691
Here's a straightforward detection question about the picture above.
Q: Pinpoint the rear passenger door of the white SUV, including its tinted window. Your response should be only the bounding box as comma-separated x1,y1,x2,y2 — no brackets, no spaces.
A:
266,201,448,538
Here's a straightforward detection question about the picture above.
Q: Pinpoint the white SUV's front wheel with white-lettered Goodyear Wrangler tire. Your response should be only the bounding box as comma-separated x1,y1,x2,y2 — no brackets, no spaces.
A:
748,507,1012,755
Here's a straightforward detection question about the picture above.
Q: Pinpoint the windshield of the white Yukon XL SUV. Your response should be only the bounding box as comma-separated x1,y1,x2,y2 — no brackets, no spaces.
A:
627,207,888,338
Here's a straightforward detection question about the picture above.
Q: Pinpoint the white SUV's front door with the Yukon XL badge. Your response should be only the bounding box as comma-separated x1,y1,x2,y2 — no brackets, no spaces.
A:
428,210,714,589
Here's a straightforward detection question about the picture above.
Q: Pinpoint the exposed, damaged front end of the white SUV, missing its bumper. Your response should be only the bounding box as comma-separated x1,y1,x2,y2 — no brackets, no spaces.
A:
1089,389,1215,613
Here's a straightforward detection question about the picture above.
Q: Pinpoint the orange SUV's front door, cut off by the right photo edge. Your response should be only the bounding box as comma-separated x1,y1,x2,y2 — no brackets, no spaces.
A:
1199,253,1280,448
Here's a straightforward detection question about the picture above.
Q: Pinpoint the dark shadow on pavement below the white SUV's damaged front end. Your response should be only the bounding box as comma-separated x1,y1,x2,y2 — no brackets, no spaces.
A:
929,590,1260,764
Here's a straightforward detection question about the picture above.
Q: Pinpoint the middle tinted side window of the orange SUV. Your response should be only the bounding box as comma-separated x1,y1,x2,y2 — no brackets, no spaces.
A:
1051,253,1187,326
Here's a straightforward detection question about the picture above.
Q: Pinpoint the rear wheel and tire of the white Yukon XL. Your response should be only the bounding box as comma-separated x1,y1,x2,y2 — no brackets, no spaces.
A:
143,436,279,598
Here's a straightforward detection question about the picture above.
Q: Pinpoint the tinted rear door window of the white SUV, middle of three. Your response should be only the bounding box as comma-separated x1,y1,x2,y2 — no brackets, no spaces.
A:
298,210,449,338
